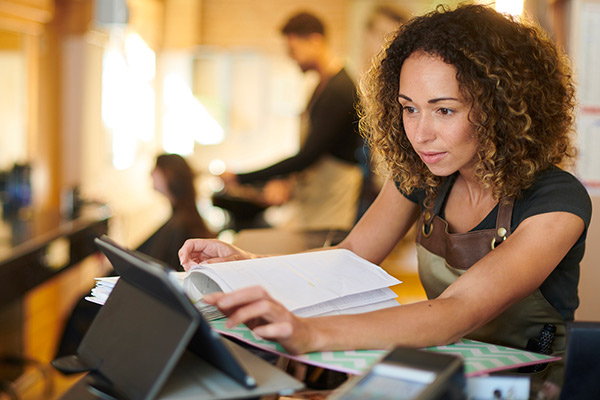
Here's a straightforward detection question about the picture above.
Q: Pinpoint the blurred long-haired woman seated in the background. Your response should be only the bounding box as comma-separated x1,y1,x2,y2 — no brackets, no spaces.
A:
56,154,215,358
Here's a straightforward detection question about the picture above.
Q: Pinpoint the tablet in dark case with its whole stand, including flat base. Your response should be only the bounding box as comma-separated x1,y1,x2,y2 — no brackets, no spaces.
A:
58,236,303,400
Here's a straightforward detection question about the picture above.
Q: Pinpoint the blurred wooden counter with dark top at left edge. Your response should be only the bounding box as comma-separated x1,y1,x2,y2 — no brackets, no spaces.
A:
0,207,109,388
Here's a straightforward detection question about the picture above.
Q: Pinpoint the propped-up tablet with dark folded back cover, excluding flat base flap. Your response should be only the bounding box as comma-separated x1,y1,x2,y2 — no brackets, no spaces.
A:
78,236,255,399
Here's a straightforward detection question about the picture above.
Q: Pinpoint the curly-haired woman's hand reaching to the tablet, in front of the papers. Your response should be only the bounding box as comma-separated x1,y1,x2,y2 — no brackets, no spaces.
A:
203,286,314,354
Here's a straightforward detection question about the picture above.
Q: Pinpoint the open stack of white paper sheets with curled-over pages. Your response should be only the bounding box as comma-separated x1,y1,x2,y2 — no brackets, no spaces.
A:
87,249,401,320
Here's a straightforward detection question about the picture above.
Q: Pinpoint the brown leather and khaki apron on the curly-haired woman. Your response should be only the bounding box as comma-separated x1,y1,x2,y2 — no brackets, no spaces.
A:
416,179,565,380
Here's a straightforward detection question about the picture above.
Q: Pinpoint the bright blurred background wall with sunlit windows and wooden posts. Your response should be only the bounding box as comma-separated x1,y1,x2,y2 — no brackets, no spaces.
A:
0,0,577,245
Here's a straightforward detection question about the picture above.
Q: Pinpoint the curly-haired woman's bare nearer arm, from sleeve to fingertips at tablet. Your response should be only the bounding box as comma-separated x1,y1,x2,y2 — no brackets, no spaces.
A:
205,212,584,353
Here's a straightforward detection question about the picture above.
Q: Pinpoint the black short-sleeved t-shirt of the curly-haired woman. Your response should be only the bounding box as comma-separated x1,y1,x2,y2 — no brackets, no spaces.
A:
405,167,592,321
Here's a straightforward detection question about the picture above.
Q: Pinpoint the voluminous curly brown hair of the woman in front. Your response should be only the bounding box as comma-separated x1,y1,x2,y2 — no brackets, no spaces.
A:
360,5,576,200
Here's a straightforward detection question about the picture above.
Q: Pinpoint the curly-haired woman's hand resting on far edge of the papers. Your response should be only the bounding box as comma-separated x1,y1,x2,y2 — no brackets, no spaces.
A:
179,239,257,271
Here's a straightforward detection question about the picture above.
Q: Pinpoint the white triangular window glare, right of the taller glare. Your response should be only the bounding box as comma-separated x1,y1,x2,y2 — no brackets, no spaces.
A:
163,74,225,155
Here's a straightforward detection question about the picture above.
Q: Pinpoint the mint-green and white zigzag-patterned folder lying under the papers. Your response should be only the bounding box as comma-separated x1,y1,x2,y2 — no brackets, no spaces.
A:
210,319,560,377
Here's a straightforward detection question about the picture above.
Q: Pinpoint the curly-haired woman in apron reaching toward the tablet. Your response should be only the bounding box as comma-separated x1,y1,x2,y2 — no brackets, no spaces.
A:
179,5,591,380
